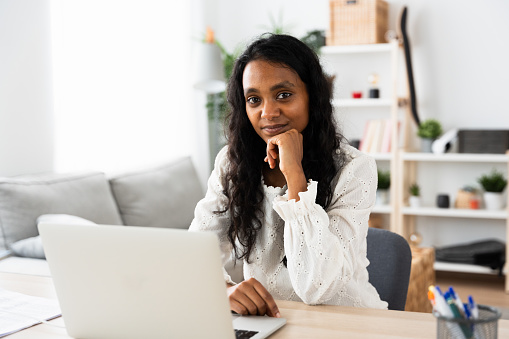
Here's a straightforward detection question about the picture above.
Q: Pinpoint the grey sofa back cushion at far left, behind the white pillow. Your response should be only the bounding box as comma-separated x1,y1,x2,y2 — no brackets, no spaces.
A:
0,172,122,250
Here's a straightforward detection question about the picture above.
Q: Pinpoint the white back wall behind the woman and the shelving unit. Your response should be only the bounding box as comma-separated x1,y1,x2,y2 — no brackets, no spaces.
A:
199,0,509,245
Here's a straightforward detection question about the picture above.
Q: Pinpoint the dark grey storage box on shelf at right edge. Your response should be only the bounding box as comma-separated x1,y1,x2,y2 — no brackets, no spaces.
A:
458,129,509,154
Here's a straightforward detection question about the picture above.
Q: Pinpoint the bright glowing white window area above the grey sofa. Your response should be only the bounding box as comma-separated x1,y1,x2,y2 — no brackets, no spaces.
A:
52,0,195,173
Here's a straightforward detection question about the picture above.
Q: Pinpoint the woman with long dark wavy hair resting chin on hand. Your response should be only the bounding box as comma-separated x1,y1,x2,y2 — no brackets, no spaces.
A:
190,35,387,317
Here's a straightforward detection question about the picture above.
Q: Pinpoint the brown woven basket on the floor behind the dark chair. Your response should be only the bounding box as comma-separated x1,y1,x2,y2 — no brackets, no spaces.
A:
405,247,435,313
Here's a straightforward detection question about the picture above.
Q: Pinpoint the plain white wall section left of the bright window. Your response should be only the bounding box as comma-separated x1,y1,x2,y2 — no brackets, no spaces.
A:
0,0,54,176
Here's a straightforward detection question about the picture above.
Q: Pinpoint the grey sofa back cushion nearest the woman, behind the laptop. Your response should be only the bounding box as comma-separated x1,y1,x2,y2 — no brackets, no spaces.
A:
110,157,203,229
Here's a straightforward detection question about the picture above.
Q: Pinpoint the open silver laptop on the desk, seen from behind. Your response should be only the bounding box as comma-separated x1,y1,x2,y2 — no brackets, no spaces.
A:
38,223,286,339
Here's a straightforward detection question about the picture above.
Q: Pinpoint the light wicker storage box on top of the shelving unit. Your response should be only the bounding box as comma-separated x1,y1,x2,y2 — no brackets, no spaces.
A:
326,0,389,45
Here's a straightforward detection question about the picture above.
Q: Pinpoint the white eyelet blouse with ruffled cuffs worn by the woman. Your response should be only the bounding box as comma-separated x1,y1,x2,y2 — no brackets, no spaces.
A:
189,146,387,309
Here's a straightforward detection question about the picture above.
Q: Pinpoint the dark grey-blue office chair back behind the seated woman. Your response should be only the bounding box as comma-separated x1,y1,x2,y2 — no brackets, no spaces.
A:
367,227,410,311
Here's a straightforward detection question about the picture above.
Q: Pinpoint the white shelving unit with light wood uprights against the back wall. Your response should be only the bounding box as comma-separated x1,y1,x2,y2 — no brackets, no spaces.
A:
321,41,509,293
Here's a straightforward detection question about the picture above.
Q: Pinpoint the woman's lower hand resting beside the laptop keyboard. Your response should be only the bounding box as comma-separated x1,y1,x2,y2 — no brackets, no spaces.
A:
227,278,281,318
